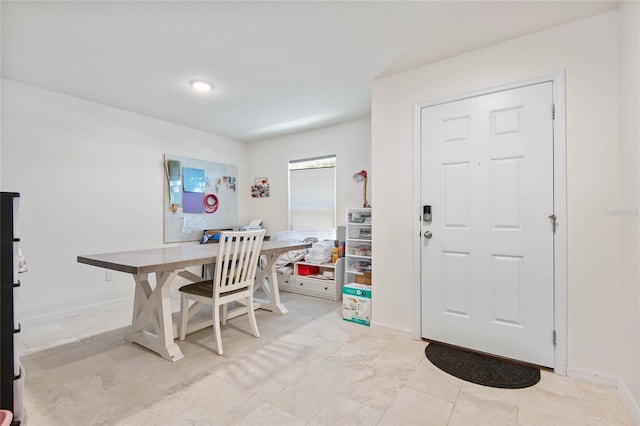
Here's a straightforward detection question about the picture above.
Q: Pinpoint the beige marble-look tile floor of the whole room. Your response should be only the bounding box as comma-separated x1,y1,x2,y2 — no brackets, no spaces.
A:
21,293,633,426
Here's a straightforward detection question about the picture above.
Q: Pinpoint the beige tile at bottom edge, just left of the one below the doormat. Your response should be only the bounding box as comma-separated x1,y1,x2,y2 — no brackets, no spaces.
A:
378,388,453,426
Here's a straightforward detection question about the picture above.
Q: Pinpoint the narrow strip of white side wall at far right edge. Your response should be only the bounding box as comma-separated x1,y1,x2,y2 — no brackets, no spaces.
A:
616,2,640,412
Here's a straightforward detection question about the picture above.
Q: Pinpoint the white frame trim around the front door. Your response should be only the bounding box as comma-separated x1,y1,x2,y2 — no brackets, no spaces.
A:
412,71,568,376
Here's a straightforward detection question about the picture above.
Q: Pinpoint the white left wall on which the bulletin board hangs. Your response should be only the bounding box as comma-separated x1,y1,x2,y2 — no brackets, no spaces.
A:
1,80,250,319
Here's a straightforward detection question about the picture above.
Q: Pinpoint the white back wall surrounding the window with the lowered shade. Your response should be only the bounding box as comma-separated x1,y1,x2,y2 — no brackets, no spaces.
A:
247,118,377,234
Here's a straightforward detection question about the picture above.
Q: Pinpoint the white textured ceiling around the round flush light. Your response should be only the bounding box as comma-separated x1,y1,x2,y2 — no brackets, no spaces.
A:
0,1,617,141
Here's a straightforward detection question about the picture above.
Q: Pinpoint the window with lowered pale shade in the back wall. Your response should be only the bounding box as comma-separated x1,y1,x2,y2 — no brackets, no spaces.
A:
289,155,336,230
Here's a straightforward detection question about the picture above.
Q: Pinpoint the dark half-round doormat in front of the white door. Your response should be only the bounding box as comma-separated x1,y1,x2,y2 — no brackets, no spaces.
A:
424,342,540,389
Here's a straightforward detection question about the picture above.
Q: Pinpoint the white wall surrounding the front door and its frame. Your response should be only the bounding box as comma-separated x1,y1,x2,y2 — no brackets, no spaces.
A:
372,11,637,386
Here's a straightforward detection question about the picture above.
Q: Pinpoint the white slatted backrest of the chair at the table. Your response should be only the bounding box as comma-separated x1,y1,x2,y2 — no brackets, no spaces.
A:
213,229,266,294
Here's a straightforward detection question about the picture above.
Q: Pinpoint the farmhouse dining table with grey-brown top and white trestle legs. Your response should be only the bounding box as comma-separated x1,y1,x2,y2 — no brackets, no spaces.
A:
78,241,311,361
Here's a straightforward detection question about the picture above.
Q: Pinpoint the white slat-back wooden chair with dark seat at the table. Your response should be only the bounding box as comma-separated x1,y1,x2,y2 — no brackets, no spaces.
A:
178,229,266,355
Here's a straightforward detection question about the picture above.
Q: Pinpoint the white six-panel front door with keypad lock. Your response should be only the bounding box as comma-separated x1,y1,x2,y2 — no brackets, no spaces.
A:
421,82,554,367
